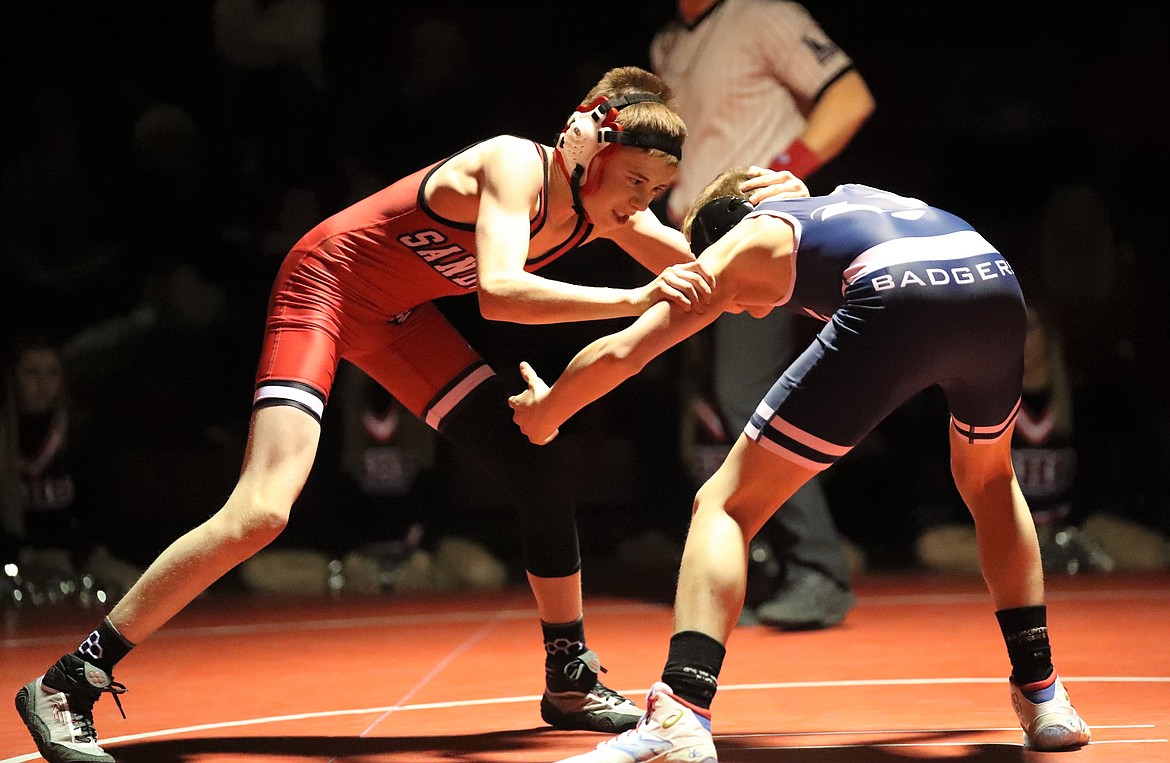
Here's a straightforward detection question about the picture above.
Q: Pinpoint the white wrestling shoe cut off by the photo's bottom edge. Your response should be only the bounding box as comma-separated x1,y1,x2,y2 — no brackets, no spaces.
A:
559,682,718,763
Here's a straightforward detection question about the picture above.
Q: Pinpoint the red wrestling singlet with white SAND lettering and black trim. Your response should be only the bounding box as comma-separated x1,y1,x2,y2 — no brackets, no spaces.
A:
255,143,592,428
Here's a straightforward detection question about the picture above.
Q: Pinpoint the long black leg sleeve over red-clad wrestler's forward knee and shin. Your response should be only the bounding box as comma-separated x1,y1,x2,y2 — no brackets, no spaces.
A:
439,377,580,578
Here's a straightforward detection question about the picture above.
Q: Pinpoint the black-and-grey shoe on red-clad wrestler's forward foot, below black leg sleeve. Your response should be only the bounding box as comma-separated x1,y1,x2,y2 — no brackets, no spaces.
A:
541,649,642,734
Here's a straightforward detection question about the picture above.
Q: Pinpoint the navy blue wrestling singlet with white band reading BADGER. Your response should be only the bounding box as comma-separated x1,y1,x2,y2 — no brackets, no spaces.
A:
745,185,1025,468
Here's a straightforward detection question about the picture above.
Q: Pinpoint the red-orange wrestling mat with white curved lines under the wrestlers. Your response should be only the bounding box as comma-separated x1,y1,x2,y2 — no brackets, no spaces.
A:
0,570,1170,763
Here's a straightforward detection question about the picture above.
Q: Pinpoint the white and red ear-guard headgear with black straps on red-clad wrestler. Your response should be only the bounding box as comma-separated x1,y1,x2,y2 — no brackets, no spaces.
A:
556,92,682,215
